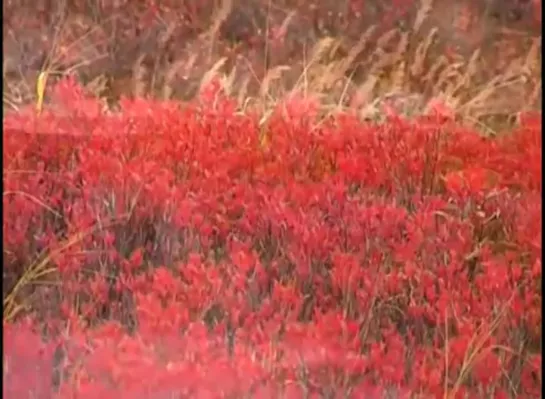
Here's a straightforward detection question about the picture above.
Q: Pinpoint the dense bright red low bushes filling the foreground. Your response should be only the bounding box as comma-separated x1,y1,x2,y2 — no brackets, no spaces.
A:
3,81,542,398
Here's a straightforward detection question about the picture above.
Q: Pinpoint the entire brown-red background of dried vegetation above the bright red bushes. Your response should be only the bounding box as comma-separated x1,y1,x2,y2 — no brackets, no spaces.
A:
3,0,541,132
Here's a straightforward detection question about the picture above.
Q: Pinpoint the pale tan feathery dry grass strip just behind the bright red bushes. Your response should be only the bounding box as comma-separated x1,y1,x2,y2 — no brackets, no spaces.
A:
3,0,541,133
